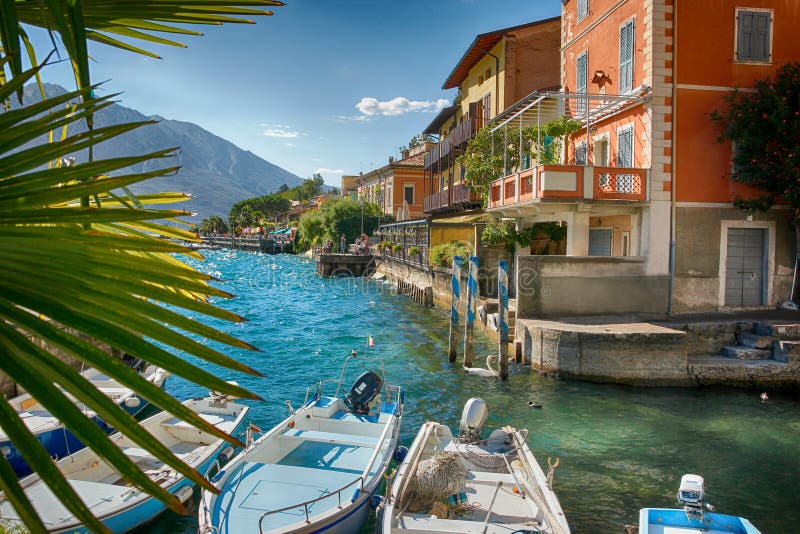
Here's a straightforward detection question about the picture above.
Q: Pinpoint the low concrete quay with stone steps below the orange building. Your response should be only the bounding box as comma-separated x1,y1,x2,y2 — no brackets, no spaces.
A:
516,311,800,390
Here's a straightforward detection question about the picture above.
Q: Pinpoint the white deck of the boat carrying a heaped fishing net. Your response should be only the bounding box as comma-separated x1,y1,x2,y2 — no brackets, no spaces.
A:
398,471,539,534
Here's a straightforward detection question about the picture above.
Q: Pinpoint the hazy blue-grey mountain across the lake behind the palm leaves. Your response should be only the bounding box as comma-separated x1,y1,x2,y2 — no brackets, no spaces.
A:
12,84,303,223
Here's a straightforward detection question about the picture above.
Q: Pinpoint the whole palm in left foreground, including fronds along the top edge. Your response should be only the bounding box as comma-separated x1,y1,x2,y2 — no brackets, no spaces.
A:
0,0,282,532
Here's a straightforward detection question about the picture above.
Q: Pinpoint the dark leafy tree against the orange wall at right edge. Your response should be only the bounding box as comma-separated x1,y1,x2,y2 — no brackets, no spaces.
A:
711,63,800,221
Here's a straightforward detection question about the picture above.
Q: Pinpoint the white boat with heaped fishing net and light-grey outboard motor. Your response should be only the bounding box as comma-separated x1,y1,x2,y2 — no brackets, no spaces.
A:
380,398,570,534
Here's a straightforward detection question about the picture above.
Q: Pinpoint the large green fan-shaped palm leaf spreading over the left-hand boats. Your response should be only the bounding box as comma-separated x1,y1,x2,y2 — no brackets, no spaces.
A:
0,66,258,531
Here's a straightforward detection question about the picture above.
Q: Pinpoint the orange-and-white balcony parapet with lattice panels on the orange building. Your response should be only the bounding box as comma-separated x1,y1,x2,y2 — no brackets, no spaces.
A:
488,165,649,209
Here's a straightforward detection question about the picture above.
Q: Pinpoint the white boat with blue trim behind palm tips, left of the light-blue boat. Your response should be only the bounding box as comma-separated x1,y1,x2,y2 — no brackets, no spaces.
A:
0,395,248,533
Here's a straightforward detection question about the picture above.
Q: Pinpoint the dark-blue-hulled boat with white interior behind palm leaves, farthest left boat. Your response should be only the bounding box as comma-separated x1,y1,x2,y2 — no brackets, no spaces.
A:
0,365,169,477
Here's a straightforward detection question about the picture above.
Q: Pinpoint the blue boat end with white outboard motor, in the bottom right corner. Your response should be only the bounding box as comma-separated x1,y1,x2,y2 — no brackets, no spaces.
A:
639,474,761,534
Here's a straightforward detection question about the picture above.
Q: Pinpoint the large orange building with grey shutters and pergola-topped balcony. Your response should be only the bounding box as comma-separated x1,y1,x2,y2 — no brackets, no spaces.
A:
489,0,800,316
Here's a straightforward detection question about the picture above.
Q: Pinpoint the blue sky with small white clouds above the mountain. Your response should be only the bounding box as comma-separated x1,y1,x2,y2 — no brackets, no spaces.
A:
28,0,561,186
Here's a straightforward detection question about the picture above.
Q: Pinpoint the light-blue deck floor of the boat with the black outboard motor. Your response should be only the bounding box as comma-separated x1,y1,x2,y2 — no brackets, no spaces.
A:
213,440,379,532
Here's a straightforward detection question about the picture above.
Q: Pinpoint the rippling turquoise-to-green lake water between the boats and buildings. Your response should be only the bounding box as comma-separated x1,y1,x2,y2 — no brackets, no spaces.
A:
143,251,800,534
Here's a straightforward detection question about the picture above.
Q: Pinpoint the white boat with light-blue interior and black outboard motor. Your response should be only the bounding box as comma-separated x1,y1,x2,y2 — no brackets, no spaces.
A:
198,351,402,534
